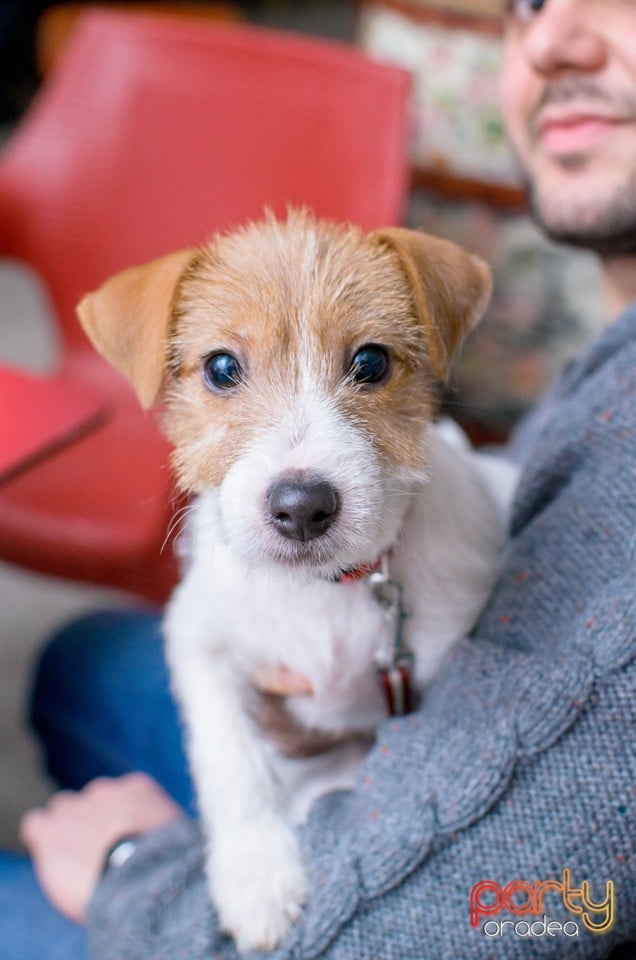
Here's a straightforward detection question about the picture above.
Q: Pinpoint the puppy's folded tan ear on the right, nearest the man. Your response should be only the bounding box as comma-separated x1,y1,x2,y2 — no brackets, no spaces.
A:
371,227,492,380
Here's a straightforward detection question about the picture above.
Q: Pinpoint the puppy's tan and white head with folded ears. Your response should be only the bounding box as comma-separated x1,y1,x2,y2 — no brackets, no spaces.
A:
80,213,490,576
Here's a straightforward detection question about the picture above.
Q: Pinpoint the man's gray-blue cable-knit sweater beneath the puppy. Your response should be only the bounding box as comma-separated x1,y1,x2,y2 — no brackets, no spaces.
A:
90,304,636,960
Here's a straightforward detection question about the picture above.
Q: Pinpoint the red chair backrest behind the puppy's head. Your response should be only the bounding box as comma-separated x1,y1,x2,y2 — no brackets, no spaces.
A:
0,11,408,350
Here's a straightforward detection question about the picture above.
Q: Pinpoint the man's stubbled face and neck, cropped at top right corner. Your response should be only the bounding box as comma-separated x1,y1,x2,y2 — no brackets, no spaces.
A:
501,0,636,317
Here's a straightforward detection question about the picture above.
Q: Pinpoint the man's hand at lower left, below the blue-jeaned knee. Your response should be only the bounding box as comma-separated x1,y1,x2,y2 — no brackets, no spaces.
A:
20,773,182,923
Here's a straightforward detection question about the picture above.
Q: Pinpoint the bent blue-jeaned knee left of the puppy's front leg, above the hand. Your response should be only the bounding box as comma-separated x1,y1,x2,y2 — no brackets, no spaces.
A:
31,610,194,813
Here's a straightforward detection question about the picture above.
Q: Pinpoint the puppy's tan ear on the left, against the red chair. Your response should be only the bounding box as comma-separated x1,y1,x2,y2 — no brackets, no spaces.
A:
77,249,196,408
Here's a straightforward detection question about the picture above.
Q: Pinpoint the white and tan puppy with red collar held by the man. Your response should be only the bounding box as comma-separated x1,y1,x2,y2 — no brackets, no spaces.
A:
79,211,516,950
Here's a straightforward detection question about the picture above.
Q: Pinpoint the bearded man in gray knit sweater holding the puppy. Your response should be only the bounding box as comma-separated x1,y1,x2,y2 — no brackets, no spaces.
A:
0,0,636,960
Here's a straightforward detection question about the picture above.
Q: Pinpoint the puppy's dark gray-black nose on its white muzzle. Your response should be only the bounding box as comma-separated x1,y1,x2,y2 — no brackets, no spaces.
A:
266,478,340,540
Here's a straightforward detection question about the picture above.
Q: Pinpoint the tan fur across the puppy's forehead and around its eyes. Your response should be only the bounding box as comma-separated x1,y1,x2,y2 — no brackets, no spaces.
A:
164,213,434,492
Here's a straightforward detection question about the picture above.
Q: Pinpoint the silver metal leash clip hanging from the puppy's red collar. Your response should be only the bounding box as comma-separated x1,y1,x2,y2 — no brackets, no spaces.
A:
367,553,414,717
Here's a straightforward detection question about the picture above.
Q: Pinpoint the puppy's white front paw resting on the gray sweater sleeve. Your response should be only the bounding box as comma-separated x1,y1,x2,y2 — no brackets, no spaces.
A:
209,817,306,952
